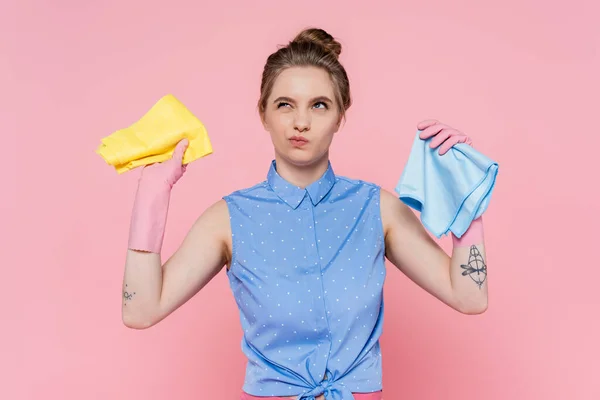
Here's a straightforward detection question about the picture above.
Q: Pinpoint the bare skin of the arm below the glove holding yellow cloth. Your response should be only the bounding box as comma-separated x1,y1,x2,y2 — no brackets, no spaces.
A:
122,200,231,329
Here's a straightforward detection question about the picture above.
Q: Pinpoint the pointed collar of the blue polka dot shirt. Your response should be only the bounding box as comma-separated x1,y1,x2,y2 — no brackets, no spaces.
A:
267,160,335,209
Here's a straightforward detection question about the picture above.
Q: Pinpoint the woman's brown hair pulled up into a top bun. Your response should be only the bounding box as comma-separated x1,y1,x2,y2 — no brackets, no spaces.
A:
258,28,352,117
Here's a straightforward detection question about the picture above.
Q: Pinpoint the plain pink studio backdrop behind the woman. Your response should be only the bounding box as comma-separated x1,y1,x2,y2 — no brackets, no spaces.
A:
5,0,600,400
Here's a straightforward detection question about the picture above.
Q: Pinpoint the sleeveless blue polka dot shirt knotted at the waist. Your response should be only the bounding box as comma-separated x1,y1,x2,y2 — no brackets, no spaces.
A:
224,161,386,400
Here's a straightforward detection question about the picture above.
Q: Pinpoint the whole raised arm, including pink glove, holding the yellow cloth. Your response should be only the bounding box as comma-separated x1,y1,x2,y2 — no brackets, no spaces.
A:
122,140,231,329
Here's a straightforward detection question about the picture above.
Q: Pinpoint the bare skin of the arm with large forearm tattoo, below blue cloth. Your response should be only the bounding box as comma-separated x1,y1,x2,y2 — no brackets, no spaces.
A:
381,189,487,314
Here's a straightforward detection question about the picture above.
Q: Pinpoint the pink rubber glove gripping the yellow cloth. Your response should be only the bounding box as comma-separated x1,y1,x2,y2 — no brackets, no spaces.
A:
128,139,189,253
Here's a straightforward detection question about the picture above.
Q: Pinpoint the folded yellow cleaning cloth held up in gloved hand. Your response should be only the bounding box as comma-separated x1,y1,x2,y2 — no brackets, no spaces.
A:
96,94,213,174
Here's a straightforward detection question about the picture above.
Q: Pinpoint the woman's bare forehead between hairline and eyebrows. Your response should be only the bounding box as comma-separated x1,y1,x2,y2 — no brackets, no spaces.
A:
271,67,334,100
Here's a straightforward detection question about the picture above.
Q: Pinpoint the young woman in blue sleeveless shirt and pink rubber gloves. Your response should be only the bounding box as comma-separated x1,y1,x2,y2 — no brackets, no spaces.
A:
122,29,487,400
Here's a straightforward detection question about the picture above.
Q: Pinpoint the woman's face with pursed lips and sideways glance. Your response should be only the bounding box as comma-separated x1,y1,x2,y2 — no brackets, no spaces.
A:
262,67,341,166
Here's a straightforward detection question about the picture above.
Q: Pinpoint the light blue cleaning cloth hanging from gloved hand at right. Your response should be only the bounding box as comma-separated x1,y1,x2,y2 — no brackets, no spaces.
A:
396,131,498,238
